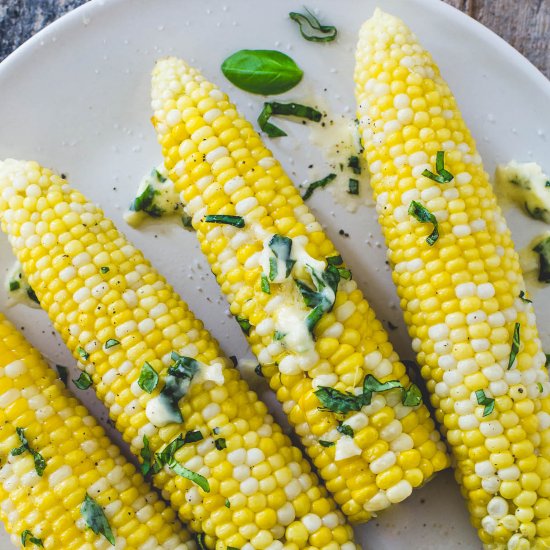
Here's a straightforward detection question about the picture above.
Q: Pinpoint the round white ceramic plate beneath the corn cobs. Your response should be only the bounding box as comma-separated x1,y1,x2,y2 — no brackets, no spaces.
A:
0,0,550,550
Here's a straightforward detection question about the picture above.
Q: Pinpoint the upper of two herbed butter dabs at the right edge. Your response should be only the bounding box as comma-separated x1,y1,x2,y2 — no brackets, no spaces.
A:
495,160,550,223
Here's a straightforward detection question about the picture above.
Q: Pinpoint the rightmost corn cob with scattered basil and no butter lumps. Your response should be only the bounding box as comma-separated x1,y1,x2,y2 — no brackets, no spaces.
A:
355,10,550,549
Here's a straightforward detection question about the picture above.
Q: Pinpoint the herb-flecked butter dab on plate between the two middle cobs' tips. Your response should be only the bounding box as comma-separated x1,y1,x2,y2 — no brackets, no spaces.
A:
124,164,183,227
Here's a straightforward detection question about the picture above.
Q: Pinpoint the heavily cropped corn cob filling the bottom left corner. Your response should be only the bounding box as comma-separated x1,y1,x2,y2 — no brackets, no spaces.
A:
0,314,196,550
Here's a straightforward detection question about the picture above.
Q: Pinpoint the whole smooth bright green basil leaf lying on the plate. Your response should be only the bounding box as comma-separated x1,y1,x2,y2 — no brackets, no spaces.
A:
222,50,304,95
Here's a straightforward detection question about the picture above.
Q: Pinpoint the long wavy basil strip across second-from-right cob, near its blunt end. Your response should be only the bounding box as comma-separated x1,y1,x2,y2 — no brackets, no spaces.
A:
314,374,422,414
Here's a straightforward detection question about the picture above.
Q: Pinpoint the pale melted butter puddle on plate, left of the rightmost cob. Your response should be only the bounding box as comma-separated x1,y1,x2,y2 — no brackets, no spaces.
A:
306,115,374,212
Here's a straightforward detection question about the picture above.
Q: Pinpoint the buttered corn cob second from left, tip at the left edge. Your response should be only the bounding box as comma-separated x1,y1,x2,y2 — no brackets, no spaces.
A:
0,160,356,550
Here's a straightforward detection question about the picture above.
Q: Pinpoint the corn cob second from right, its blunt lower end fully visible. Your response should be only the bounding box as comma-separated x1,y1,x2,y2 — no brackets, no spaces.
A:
152,58,448,521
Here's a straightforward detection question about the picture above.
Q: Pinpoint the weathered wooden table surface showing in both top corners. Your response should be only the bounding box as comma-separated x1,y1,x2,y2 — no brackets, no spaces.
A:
0,0,550,78
